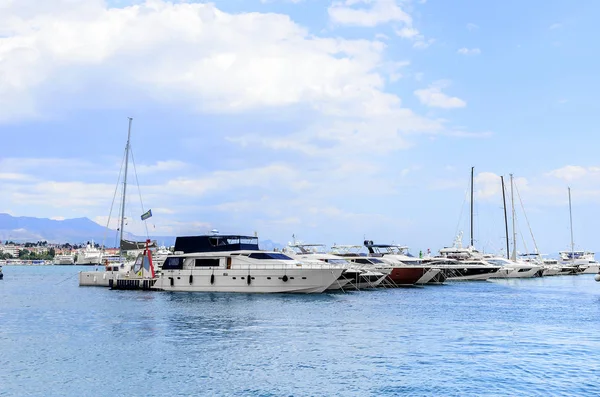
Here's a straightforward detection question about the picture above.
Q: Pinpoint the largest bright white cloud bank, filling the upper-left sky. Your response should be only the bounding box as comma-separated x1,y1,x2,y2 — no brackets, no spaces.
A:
0,0,394,121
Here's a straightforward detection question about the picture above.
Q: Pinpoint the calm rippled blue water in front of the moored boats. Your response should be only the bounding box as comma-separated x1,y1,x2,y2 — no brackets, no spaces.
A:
0,266,600,396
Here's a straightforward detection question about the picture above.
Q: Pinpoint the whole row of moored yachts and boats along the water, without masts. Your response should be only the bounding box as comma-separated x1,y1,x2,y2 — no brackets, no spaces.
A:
79,230,598,293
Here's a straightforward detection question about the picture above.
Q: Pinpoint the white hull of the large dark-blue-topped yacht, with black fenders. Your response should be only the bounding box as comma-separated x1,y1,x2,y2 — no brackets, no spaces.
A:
153,269,342,293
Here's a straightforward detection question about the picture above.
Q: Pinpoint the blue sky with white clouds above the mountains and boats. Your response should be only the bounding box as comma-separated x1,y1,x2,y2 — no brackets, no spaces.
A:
0,0,600,253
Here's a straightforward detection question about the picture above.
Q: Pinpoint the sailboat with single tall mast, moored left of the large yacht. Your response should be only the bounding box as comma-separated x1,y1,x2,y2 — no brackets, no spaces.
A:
79,117,156,289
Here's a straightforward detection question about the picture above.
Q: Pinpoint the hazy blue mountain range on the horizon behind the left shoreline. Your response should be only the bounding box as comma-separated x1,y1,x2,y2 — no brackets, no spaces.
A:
0,213,282,250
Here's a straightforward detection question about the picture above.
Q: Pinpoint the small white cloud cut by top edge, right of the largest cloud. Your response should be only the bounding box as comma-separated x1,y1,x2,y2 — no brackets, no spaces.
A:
328,0,412,27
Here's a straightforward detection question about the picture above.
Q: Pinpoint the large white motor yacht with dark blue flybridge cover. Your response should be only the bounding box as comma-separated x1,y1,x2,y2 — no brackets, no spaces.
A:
153,235,344,293
